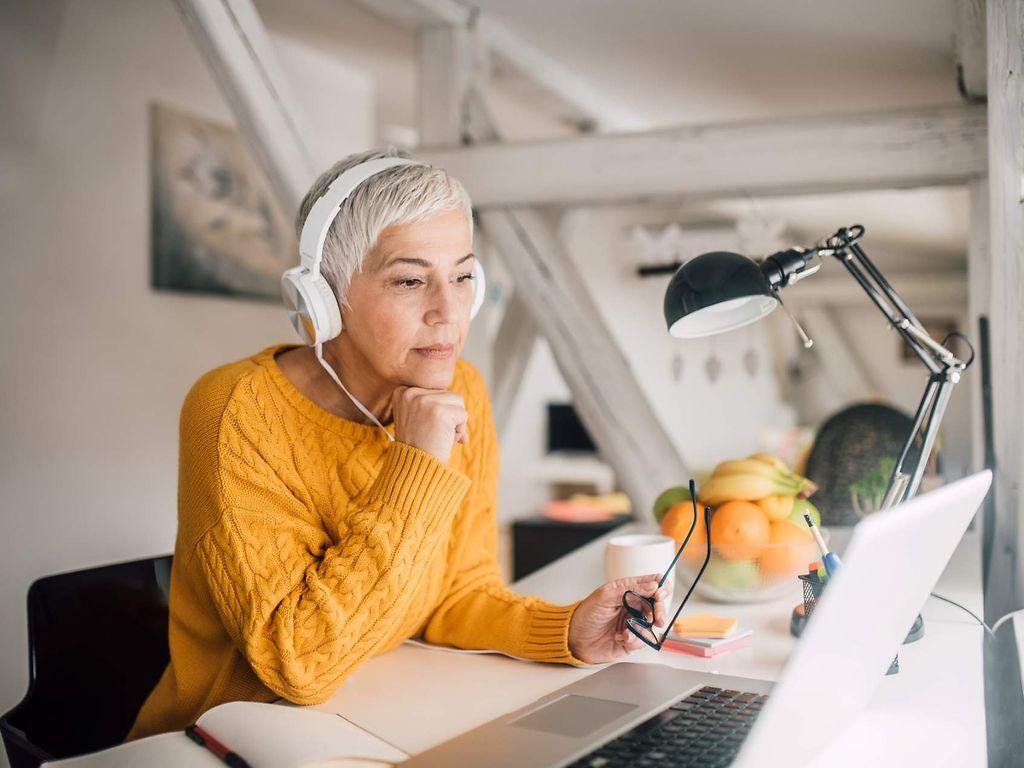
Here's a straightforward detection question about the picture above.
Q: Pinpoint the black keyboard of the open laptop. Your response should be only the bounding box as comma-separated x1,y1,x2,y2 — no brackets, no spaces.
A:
572,686,768,768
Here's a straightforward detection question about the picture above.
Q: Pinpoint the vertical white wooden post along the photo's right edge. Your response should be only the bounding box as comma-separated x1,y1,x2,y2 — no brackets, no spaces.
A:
985,0,1024,618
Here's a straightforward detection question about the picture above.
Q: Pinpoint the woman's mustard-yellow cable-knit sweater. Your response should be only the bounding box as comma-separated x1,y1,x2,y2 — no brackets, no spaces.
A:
128,345,584,739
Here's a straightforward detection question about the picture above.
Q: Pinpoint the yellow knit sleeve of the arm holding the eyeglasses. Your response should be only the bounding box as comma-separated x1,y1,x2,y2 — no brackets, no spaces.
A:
423,373,588,667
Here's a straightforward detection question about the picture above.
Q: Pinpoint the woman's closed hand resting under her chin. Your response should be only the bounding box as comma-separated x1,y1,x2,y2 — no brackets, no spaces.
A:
391,387,469,464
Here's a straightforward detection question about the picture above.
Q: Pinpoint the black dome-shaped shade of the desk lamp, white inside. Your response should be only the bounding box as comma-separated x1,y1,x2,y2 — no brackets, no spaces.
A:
665,251,778,339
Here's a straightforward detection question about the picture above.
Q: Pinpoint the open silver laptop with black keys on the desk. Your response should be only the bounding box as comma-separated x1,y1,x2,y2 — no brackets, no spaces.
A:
402,470,992,768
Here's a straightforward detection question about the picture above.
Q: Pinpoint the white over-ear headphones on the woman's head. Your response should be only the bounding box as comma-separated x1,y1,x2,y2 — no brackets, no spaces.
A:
281,158,485,346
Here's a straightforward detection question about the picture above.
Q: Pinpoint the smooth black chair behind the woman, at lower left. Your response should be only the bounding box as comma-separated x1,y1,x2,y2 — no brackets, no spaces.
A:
0,555,171,768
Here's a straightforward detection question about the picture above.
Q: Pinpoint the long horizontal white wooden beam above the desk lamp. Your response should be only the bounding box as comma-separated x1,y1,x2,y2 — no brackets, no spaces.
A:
423,105,986,207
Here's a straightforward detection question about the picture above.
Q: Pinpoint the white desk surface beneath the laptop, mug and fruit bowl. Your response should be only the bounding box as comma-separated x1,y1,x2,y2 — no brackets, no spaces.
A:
316,524,986,768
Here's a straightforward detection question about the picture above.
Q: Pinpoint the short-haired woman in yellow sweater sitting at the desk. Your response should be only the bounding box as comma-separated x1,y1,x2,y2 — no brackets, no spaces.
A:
129,152,666,739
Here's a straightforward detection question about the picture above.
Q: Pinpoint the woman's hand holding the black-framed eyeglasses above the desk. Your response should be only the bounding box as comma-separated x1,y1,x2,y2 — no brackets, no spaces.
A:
568,573,669,664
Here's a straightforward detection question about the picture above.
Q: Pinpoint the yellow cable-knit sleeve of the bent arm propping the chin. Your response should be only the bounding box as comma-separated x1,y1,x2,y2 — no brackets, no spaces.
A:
194,399,470,705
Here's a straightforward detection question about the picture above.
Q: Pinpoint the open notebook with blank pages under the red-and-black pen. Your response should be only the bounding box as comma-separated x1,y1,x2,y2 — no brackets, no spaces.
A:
44,701,409,768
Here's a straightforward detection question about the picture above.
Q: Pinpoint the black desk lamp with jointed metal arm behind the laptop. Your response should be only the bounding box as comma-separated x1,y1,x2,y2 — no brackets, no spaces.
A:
665,224,974,509
